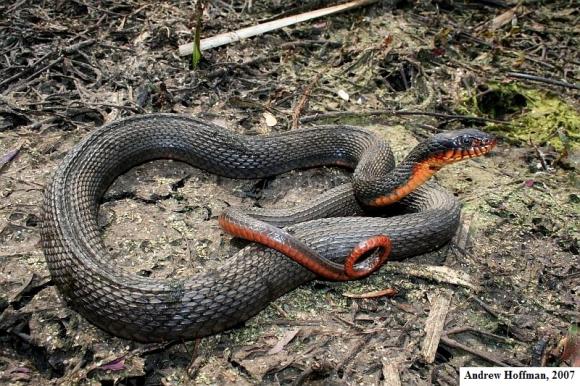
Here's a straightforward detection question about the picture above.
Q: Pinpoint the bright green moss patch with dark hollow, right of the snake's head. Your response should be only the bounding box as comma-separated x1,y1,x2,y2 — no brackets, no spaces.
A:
462,83,580,152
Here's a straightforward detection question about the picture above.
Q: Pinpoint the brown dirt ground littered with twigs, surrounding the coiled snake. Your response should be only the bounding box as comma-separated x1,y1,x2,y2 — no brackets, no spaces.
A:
0,0,580,385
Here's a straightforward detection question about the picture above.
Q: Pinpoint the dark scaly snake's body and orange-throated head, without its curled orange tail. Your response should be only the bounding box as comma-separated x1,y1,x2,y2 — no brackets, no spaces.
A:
41,113,496,342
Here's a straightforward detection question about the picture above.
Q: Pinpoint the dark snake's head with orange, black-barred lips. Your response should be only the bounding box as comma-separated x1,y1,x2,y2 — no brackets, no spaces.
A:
423,129,496,169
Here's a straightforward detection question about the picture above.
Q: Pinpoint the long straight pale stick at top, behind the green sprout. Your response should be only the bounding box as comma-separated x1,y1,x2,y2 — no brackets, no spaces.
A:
179,0,378,56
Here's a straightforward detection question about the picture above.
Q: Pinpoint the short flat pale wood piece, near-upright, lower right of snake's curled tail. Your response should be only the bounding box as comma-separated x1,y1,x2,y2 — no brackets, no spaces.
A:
421,291,451,363
